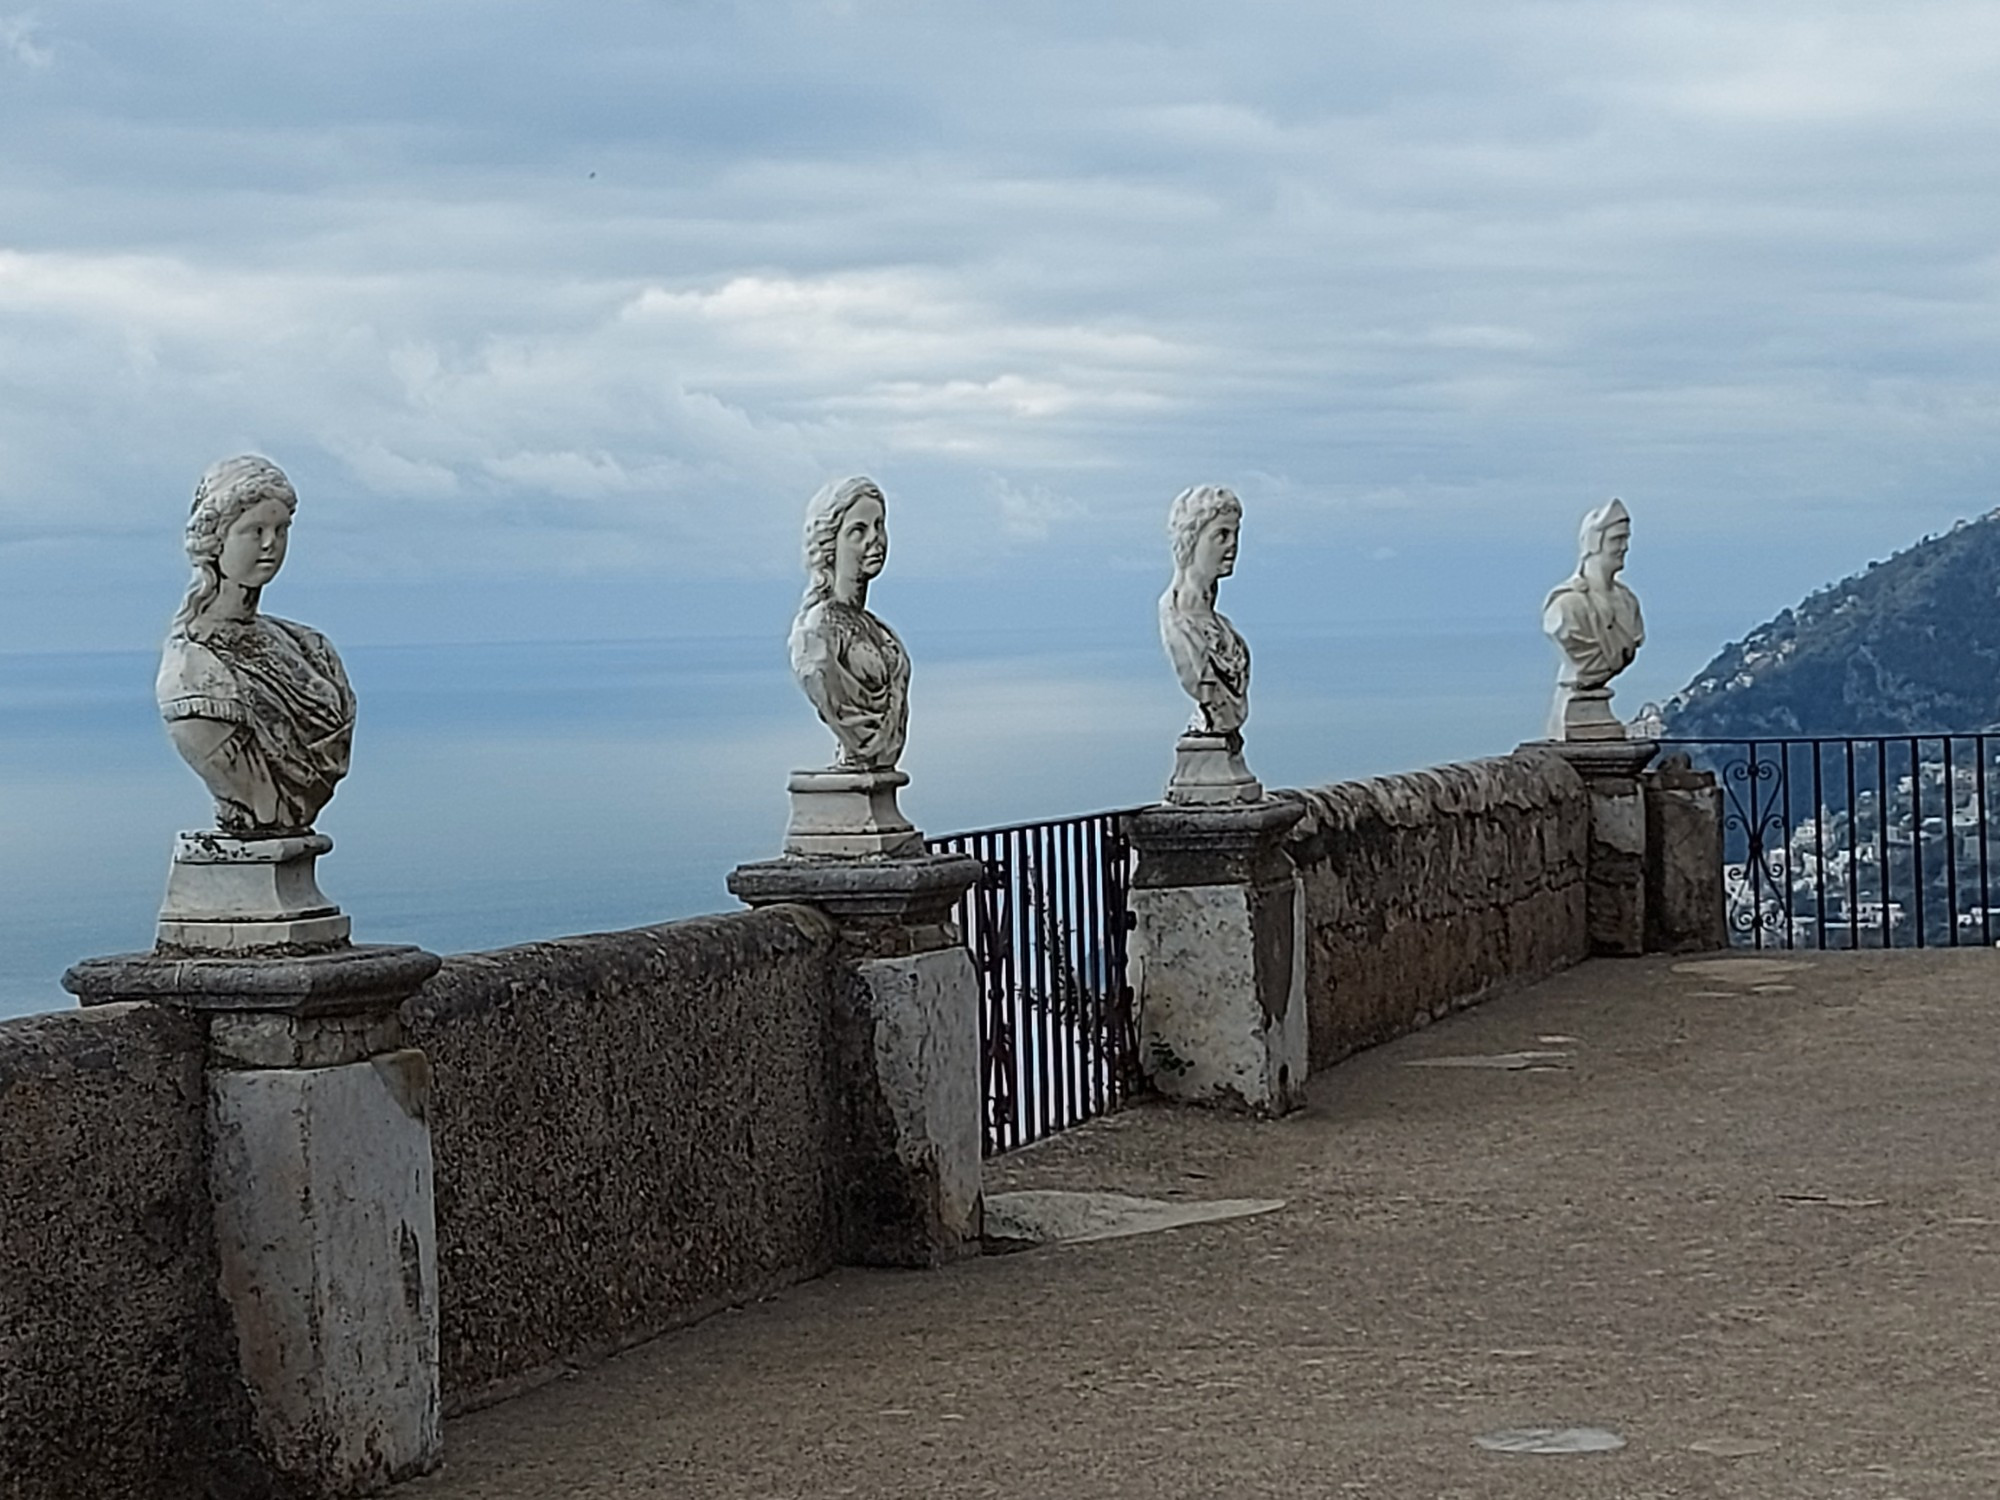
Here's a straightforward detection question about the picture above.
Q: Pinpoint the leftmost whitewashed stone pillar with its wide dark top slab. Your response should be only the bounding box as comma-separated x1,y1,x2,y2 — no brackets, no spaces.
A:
62,948,442,1496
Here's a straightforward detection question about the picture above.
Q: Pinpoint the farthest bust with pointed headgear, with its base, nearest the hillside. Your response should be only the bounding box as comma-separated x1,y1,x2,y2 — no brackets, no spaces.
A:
1542,500,1646,740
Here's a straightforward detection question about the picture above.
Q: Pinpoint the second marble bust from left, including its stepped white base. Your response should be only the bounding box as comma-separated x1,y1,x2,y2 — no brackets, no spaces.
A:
784,476,924,858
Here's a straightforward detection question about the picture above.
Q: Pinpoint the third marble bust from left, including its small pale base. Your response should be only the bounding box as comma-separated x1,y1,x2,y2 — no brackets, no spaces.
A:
1160,484,1264,806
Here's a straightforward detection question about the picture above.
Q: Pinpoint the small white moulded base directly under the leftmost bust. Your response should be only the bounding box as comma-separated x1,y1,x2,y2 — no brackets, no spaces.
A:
158,832,348,954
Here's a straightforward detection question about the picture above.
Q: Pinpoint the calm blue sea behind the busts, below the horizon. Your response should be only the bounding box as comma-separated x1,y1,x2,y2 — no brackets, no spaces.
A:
0,626,1638,1018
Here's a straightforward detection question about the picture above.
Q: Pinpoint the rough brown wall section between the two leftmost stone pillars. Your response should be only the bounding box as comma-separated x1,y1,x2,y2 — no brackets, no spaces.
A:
404,906,842,1410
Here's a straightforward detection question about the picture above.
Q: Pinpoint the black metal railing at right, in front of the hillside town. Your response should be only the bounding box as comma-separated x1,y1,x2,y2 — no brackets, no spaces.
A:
1662,732,2000,948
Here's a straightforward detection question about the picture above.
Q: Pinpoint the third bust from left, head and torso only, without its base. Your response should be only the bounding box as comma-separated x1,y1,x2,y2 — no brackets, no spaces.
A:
1160,484,1250,734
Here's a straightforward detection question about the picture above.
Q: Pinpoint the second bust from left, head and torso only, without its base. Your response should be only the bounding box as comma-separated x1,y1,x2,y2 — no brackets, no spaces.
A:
792,476,910,770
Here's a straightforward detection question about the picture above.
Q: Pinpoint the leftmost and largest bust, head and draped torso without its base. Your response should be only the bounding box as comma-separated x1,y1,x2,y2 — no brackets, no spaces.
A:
158,456,354,838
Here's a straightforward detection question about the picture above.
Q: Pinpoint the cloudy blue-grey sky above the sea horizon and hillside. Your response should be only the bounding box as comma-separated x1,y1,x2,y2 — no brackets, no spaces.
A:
0,0,2000,696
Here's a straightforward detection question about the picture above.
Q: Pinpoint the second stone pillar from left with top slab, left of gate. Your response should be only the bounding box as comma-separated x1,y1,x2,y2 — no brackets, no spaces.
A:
730,854,982,1266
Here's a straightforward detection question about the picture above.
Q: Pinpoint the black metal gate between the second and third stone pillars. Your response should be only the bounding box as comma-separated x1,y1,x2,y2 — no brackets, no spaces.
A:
930,812,1140,1156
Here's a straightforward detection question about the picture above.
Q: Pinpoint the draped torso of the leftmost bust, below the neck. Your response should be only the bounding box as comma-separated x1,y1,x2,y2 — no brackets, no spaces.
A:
156,614,354,836
